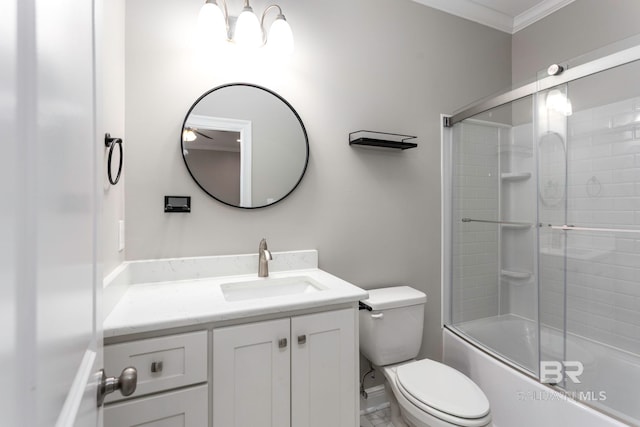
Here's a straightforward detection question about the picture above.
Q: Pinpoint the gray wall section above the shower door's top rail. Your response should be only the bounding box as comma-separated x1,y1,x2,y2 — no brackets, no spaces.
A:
512,0,640,85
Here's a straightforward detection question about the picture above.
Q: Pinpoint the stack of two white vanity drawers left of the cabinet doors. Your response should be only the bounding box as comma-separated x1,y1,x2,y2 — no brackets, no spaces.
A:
104,331,209,427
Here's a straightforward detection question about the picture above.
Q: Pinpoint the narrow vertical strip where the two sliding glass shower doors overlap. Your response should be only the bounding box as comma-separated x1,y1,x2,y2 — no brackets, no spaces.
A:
535,84,571,392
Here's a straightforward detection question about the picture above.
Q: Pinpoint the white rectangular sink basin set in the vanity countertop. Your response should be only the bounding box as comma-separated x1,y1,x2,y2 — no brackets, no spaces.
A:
220,276,326,301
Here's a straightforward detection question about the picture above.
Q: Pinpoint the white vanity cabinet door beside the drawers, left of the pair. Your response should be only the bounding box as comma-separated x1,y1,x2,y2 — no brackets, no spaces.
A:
213,319,291,427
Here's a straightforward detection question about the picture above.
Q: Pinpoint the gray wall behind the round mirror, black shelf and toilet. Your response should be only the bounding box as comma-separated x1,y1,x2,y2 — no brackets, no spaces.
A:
126,0,511,358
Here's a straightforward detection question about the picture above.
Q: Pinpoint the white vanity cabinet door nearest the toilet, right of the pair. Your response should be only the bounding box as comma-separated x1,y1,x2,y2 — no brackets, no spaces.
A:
291,309,358,427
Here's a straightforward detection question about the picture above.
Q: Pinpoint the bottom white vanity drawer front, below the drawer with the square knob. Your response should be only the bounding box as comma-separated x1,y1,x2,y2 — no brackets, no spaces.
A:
104,385,209,427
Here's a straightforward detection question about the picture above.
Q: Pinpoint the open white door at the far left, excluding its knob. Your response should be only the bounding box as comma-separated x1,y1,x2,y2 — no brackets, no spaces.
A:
0,0,102,427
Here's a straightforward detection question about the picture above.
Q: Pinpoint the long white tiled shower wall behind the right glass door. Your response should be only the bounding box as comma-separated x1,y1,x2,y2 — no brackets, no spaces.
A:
540,98,640,357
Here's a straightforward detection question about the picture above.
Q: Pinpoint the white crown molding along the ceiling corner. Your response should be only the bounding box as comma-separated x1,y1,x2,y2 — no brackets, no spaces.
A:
413,0,575,34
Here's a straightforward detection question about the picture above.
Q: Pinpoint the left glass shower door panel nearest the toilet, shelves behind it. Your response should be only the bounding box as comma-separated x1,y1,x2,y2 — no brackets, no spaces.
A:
449,96,538,374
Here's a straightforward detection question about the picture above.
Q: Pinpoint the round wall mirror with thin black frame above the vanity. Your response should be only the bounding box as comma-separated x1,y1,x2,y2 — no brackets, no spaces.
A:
180,83,309,209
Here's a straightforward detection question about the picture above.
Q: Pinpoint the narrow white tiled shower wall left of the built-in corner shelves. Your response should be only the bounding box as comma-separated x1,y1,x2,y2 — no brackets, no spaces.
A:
451,121,501,323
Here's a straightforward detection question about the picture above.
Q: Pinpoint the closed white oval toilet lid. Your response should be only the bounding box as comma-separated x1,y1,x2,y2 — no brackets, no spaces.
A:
396,359,490,418
